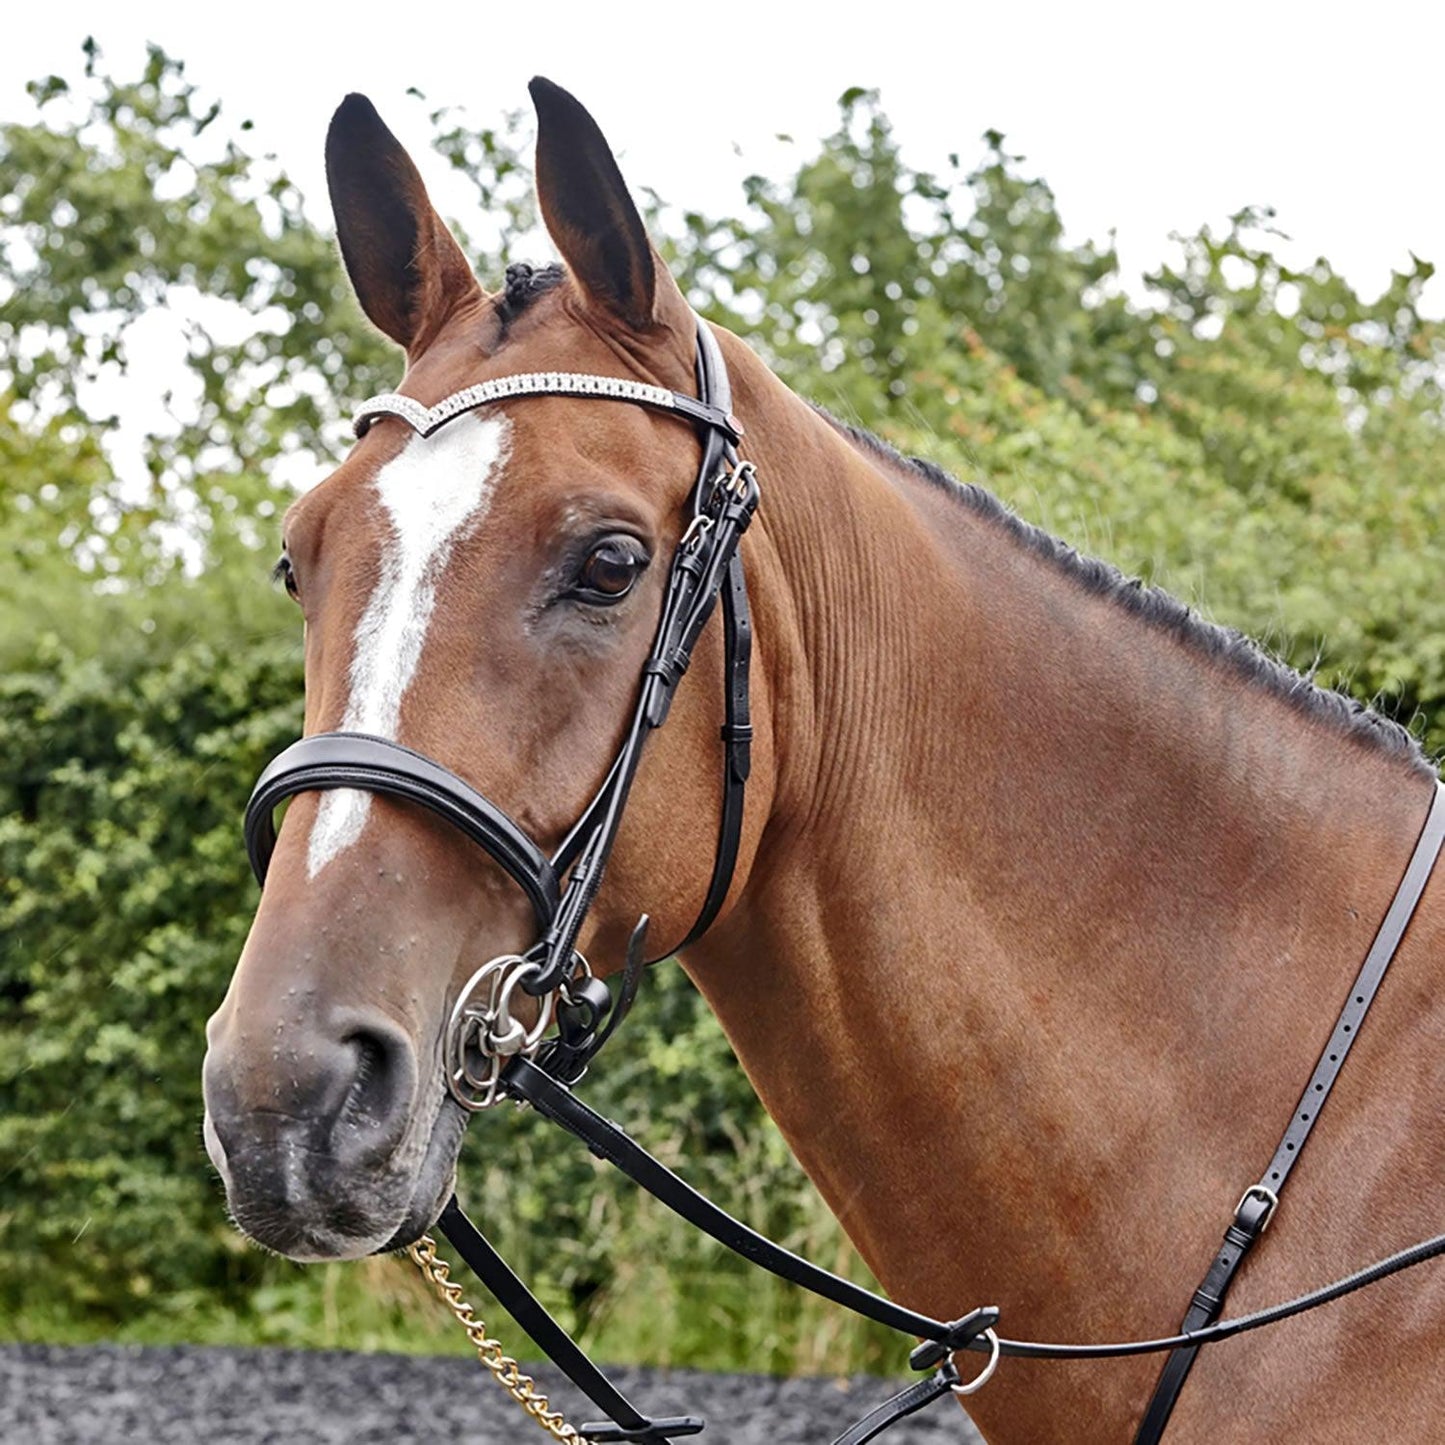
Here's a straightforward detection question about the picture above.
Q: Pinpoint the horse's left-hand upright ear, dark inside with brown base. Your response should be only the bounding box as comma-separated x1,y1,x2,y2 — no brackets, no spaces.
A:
327,95,481,353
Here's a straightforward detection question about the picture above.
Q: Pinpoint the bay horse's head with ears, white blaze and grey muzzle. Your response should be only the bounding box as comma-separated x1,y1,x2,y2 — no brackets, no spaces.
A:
205,79,767,1260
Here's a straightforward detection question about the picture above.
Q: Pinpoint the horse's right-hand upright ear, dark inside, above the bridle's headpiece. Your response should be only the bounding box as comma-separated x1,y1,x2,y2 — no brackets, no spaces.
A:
527,75,657,329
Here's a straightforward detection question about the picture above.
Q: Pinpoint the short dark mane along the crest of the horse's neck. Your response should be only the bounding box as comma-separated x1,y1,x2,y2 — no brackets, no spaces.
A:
815,407,1436,777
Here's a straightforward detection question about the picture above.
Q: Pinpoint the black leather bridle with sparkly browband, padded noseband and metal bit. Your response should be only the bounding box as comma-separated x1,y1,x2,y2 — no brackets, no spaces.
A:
246,319,759,1110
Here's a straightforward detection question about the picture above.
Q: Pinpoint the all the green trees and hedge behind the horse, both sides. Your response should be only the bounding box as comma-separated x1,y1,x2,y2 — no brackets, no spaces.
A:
0,51,1445,1370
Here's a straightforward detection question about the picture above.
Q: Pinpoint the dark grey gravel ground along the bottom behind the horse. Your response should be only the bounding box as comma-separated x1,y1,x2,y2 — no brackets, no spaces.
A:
0,1345,981,1445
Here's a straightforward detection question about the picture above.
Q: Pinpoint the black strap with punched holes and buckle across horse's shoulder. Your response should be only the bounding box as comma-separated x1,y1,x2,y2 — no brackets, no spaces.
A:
1134,783,1445,1445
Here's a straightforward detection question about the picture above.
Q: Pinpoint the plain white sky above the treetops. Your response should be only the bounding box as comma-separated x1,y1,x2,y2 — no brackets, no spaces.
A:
0,0,1445,315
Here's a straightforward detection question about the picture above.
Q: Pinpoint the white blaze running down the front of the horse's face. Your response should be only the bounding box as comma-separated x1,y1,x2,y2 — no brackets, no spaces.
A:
306,415,507,879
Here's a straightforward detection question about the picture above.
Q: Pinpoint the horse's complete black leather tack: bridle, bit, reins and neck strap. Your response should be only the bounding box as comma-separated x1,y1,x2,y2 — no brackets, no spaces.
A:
246,318,1445,1445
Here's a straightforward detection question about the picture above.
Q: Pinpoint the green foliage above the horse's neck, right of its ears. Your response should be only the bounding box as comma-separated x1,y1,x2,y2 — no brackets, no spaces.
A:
672,90,1445,753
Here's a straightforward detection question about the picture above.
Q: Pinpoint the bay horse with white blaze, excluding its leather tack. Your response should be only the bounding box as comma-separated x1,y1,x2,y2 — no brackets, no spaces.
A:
204,81,1445,1445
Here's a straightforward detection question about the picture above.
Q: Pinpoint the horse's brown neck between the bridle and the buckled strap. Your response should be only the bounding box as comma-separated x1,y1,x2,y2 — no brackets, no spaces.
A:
688,338,1428,1439
